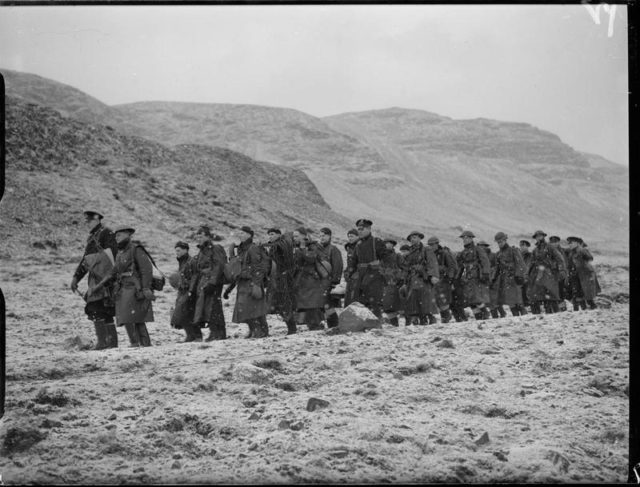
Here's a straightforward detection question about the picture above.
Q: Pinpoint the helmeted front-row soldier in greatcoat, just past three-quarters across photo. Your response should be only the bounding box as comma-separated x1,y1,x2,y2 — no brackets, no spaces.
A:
494,232,527,316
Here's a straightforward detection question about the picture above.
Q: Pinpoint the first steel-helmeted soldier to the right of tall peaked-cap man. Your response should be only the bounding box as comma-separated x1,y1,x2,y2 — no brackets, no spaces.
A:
402,231,440,325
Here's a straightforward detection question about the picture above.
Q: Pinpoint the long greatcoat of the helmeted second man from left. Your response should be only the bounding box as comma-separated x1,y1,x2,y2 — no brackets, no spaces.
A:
111,240,153,326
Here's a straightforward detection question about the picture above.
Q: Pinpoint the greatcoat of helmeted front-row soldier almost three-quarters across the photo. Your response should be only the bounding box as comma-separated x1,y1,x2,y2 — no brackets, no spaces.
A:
457,242,491,307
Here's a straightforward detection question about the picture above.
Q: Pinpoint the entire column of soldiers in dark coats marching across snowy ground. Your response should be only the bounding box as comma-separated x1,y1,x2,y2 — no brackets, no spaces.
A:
71,210,600,349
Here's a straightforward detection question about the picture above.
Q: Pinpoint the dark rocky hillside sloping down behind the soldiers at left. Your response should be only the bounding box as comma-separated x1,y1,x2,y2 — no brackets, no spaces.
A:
0,95,351,260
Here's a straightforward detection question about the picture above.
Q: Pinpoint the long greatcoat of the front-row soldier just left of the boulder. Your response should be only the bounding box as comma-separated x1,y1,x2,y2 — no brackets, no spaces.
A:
293,241,331,310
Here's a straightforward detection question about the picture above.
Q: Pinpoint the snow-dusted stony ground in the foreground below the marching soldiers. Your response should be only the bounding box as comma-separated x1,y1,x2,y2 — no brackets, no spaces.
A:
0,261,629,484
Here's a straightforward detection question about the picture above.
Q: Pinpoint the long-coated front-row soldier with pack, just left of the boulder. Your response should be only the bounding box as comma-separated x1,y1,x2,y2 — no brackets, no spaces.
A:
293,227,332,330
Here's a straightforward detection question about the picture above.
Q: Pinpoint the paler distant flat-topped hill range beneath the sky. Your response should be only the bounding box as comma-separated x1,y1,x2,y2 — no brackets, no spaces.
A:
2,67,629,250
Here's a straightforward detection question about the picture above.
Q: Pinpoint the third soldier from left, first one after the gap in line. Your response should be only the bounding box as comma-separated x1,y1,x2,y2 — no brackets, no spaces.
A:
169,241,202,343
